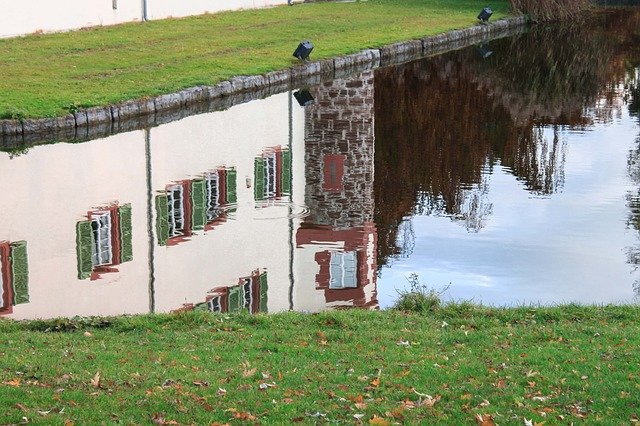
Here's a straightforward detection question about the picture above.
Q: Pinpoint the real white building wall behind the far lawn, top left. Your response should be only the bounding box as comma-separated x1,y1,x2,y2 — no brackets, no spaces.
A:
0,0,287,37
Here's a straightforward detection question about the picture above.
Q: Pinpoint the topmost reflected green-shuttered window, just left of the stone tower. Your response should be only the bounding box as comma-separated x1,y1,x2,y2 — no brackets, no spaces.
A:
253,148,291,201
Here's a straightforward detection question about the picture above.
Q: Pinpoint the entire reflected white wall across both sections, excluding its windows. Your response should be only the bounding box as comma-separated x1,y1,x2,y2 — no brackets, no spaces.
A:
0,93,310,318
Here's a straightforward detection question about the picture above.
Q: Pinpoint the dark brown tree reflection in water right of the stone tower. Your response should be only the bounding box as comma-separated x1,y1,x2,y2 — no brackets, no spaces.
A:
374,10,640,280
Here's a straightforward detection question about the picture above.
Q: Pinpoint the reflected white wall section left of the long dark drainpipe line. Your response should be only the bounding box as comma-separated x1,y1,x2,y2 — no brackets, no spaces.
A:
0,132,149,318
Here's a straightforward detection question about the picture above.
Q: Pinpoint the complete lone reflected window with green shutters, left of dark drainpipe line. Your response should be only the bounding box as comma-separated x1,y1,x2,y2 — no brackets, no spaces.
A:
76,204,133,280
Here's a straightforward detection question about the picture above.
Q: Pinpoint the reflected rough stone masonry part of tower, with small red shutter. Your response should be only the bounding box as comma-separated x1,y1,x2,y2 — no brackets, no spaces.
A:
305,72,374,229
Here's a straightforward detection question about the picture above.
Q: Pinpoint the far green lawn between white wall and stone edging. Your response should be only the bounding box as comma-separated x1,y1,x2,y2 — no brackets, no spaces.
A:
0,0,509,118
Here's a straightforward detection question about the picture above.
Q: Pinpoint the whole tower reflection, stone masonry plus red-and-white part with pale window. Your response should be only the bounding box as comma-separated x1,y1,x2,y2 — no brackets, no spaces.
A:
296,72,378,307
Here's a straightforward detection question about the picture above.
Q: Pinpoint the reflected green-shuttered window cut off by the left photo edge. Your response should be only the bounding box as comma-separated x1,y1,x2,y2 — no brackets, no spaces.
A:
0,241,29,315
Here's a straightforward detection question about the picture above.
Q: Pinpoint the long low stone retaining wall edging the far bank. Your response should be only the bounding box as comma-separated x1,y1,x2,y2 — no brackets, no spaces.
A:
0,16,527,148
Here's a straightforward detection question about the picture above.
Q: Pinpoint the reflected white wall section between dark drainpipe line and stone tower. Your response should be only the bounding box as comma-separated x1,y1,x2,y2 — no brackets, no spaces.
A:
151,93,304,312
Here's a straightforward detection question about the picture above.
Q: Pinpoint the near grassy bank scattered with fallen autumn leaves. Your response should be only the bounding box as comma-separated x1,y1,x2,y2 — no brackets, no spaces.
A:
0,304,640,425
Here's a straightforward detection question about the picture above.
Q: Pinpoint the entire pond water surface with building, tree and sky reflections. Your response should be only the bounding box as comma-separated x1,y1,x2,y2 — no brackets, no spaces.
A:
0,9,640,318
